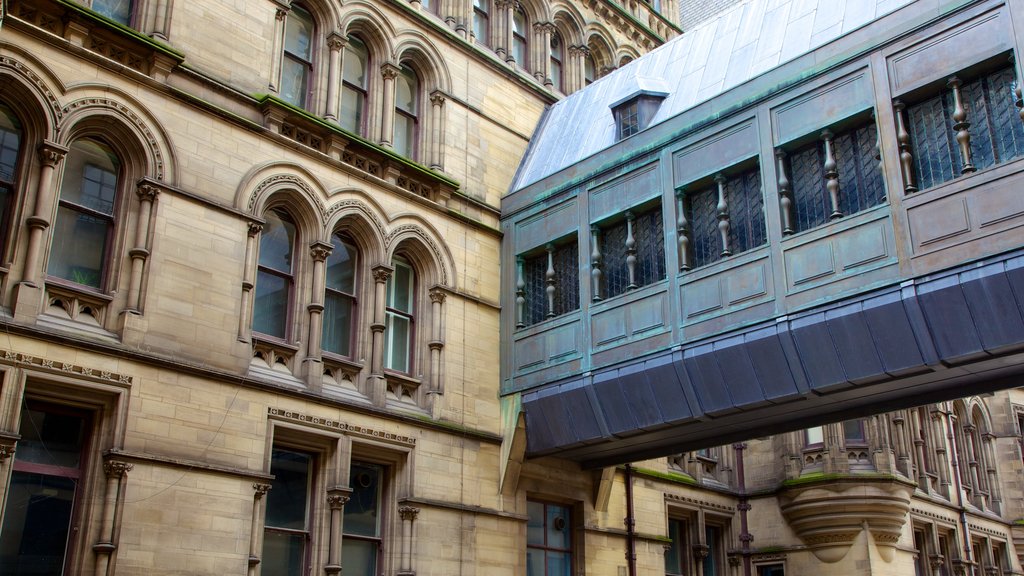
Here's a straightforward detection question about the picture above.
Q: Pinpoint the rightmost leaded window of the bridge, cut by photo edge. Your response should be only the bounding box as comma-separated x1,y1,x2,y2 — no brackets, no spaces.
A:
895,61,1024,192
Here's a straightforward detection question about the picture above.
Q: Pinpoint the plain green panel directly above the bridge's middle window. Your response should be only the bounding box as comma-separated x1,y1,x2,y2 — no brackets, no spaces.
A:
673,122,758,188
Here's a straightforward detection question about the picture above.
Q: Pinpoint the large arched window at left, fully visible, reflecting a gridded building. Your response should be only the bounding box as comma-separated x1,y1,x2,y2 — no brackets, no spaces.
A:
46,138,121,290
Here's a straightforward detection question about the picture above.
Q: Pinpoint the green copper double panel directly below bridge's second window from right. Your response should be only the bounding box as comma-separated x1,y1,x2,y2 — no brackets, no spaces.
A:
782,212,896,292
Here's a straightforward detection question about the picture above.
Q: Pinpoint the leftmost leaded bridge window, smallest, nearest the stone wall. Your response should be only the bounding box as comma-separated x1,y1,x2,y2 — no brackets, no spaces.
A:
516,236,580,328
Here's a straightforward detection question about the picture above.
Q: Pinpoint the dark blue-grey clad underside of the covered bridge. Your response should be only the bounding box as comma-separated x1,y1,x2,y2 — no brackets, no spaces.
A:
522,250,1024,467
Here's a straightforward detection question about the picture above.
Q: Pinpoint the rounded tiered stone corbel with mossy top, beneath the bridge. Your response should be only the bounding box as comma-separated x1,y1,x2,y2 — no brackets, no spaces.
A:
779,475,914,563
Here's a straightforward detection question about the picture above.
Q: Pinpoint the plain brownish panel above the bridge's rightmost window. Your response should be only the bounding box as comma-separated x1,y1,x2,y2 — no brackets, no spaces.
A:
889,10,1013,96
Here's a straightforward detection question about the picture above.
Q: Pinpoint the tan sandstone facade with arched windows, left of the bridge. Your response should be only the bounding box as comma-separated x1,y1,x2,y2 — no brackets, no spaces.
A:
0,0,678,576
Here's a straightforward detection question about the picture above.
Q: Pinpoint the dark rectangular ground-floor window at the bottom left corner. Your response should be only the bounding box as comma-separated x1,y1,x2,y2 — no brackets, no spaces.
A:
0,402,89,576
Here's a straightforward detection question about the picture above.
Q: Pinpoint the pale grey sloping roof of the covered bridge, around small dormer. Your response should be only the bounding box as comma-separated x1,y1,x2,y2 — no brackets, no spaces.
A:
510,0,914,192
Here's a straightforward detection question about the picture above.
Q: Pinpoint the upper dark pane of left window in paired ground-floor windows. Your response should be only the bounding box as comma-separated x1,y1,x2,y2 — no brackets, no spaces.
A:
266,448,312,530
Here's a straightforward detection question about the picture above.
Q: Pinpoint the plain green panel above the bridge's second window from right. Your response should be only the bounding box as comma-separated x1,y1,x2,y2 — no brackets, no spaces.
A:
772,70,874,146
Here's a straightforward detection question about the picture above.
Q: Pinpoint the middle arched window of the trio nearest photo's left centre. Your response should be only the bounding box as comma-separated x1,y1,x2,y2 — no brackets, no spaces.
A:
323,234,358,357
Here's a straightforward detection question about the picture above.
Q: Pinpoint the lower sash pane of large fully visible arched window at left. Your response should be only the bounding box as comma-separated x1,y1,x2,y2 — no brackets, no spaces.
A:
46,206,111,288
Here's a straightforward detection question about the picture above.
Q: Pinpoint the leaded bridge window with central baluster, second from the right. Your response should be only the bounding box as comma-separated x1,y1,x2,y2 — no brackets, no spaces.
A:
779,116,886,234
